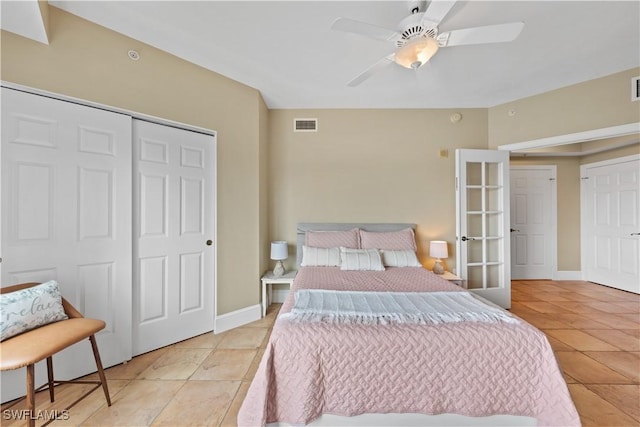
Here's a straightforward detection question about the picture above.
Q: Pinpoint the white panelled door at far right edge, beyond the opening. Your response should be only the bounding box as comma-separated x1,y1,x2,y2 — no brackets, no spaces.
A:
580,155,640,293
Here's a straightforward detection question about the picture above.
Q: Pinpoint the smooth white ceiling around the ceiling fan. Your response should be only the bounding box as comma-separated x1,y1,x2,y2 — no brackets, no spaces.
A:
3,0,640,108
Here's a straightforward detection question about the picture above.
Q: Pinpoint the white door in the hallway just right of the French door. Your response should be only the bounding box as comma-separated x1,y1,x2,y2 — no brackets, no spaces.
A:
509,166,556,279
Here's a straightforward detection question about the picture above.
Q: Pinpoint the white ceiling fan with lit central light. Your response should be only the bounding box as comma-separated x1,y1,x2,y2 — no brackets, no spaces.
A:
331,0,524,86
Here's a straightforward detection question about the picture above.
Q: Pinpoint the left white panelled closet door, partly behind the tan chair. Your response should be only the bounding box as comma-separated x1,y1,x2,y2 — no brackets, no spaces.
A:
0,88,132,400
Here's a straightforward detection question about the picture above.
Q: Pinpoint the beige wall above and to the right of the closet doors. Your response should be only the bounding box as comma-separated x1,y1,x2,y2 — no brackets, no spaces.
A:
1,7,267,314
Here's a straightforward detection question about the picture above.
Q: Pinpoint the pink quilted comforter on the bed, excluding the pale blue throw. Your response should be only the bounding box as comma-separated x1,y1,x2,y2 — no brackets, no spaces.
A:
238,267,580,426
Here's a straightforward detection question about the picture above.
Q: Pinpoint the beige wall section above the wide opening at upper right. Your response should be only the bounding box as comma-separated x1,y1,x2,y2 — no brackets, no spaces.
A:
489,68,640,148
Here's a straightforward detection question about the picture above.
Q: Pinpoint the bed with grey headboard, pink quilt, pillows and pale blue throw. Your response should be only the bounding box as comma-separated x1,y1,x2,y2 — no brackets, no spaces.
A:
238,223,580,426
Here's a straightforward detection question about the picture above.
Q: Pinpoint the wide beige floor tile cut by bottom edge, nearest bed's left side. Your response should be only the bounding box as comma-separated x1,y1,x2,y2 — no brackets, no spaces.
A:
152,381,240,427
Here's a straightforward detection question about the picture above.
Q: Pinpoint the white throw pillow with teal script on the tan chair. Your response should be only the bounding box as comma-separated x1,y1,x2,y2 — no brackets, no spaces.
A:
0,280,68,341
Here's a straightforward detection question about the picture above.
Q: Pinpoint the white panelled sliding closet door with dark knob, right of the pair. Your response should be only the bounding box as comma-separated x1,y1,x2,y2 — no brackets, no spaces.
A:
133,120,215,355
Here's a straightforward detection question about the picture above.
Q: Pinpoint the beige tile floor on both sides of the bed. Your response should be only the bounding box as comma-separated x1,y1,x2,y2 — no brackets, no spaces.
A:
1,281,640,427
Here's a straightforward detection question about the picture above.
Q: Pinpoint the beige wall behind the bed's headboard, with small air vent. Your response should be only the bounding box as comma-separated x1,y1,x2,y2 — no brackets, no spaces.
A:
269,109,487,268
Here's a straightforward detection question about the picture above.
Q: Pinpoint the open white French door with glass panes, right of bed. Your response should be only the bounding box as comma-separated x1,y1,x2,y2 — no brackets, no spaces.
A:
456,150,511,308
